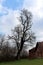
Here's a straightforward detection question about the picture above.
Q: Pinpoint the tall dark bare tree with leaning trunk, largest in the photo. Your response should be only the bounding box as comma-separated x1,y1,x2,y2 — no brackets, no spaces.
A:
9,9,36,59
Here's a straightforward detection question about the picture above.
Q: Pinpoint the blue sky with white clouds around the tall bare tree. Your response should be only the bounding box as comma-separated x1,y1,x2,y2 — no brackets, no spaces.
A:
0,0,43,41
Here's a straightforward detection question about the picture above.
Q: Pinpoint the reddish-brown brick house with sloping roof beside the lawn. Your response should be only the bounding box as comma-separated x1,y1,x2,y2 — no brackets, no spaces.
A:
29,42,43,59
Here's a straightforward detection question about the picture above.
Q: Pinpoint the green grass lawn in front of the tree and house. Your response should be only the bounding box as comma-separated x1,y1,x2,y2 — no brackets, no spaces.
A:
0,59,43,65
